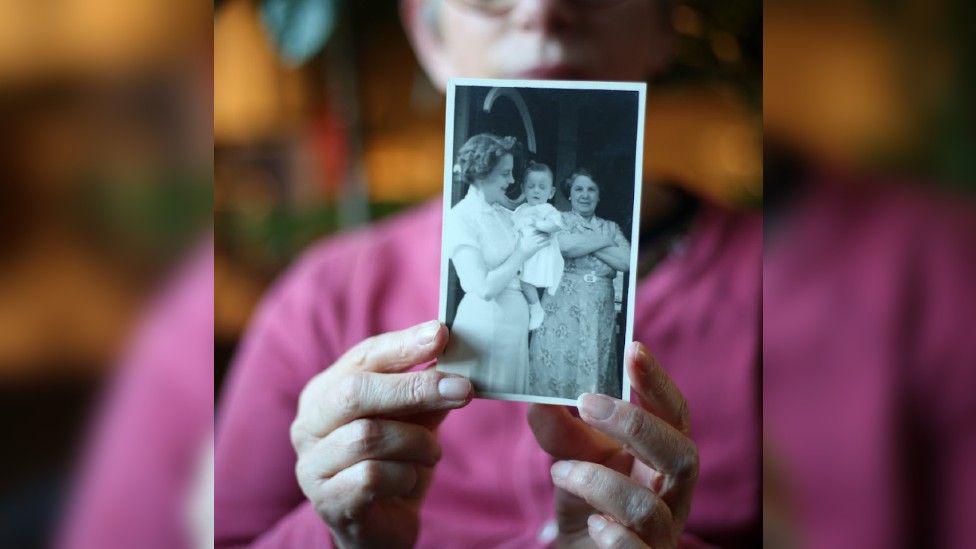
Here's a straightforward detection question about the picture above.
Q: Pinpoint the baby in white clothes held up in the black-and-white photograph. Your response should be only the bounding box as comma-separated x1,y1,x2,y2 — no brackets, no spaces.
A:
512,161,565,330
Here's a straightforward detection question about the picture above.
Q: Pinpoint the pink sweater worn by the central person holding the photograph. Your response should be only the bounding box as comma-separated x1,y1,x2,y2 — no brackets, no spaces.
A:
215,202,762,548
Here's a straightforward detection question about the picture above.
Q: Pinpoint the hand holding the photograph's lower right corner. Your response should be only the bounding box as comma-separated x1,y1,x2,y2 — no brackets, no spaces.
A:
529,343,698,549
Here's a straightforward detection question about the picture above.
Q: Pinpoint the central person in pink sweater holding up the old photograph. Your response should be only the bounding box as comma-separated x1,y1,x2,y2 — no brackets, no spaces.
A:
215,0,762,547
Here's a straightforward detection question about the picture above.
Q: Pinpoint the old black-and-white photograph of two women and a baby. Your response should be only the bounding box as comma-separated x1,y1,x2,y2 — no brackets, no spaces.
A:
437,79,646,404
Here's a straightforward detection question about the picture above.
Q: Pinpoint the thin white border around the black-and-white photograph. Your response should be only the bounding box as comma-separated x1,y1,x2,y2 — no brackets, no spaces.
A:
437,78,647,406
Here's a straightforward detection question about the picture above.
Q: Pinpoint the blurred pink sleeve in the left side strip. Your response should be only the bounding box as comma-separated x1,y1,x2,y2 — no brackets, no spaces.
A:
57,242,213,549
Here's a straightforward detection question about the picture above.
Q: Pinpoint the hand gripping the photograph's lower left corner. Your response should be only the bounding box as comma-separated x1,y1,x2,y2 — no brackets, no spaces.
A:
291,321,471,547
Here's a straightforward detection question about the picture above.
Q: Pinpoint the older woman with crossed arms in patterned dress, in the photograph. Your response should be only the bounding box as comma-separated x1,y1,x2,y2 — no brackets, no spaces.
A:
529,169,630,398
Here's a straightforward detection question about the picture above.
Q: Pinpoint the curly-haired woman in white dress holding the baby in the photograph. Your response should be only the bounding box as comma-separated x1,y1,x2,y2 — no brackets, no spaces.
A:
441,134,549,393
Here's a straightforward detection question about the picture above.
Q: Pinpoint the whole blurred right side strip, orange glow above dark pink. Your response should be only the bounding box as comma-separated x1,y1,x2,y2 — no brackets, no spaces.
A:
762,2,976,548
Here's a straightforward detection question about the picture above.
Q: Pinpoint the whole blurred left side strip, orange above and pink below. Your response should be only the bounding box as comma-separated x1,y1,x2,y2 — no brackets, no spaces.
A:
0,0,219,548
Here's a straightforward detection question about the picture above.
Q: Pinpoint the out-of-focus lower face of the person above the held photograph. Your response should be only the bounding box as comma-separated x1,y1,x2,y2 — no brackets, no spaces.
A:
408,0,670,87
